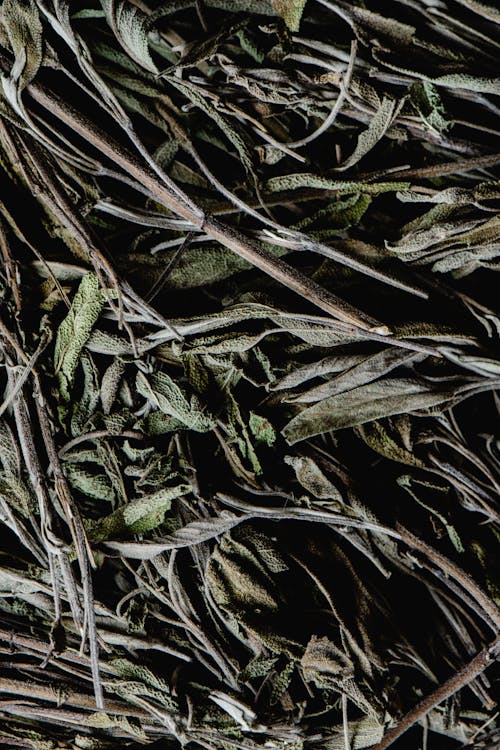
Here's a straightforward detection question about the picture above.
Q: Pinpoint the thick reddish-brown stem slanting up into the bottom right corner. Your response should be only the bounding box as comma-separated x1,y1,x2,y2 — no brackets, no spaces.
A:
372,636,500,750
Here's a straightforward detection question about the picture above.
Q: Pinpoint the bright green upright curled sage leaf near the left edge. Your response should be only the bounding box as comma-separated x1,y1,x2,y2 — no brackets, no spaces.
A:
54,273,106,401
